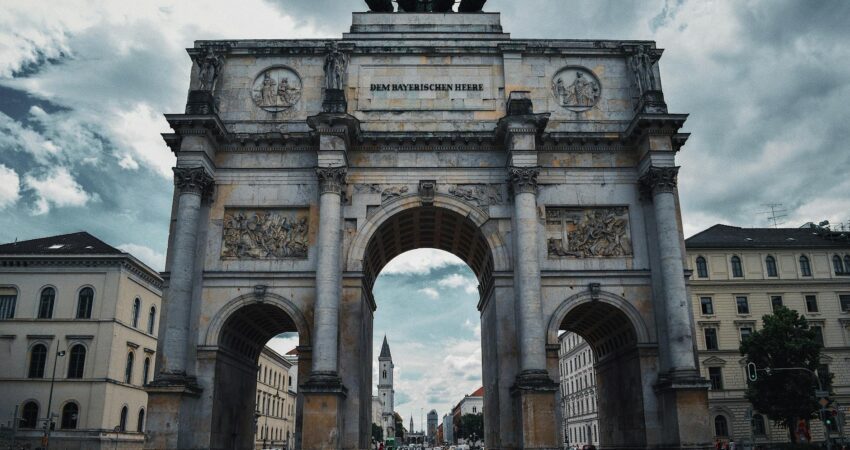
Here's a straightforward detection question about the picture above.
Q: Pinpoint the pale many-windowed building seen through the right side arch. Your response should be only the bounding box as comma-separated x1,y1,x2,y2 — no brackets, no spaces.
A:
558,332,599,446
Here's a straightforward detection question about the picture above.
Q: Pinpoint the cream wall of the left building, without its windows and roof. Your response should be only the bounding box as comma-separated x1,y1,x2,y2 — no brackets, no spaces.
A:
0,258,161,449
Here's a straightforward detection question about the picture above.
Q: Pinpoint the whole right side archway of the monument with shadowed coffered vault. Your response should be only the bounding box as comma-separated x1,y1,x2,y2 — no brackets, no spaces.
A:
550,295,648,448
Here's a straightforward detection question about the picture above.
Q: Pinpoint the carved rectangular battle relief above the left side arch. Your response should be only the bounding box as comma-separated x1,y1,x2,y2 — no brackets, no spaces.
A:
221,208,310,259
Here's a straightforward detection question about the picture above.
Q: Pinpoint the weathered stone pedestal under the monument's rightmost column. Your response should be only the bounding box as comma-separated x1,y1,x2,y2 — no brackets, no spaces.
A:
654,369,712,450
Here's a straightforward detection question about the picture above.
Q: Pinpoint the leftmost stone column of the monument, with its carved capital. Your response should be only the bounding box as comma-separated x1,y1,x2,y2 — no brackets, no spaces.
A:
160,167,213,375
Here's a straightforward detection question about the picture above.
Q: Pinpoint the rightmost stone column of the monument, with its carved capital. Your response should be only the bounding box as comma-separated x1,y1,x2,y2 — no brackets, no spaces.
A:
640,166,697,377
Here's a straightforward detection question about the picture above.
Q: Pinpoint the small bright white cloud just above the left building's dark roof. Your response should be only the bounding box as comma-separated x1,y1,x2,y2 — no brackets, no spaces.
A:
24,167,99,215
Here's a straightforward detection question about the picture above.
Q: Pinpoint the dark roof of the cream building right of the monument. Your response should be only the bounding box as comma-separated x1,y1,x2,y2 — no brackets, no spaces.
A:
685,224,850,249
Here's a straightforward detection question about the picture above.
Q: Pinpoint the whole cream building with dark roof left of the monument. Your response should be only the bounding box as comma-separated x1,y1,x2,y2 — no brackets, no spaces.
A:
0,233,162,449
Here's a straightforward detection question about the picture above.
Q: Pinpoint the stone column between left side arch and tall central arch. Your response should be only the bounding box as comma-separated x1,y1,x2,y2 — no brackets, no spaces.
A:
313,167,346,375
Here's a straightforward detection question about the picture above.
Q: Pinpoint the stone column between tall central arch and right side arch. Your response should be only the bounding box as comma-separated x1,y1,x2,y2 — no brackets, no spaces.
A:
508,167,546,374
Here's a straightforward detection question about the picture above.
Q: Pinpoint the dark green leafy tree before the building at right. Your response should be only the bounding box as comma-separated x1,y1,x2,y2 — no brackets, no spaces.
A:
740,307,832,442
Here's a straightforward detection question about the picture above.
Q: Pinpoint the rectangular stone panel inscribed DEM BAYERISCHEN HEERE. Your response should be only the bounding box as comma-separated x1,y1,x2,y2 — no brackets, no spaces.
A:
357,65,498,111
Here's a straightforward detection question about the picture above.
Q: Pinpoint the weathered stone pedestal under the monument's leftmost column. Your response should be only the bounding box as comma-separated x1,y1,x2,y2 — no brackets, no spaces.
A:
145,374,203,449
